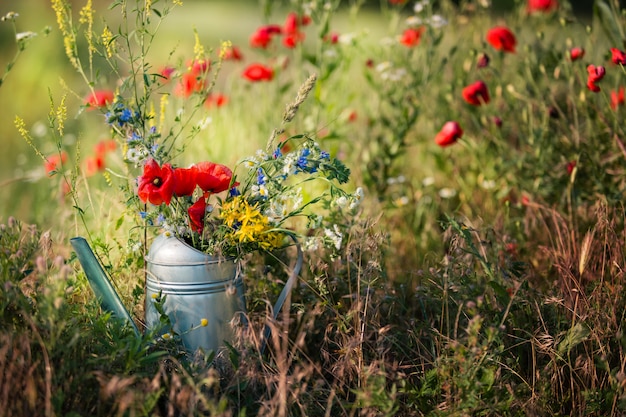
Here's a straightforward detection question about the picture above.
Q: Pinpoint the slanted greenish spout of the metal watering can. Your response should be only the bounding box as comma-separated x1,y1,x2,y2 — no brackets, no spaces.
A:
70,237,141,337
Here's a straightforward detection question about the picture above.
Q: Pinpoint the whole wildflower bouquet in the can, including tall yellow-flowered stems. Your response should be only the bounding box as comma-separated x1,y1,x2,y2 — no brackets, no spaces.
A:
47,0,362,256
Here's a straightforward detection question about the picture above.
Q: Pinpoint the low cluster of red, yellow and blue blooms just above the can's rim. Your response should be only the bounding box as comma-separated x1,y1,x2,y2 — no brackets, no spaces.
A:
137,117,354,256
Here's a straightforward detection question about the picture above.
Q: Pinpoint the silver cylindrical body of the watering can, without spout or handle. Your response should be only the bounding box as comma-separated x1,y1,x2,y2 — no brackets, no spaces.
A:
145,234,246,353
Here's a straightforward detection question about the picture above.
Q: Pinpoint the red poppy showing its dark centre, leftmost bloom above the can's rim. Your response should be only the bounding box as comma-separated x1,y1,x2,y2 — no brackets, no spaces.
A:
137,159,174,205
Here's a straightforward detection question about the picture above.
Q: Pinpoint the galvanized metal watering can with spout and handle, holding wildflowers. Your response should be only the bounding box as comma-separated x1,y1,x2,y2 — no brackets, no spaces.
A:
70,235,303,354
